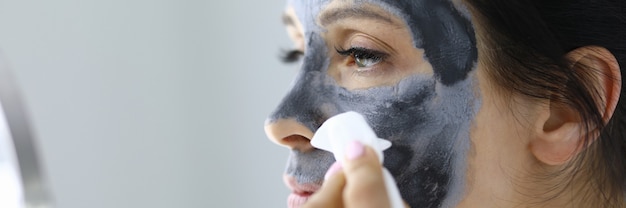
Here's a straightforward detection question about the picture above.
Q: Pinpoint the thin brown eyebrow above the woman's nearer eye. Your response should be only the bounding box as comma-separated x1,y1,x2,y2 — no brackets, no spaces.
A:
319,8,395,27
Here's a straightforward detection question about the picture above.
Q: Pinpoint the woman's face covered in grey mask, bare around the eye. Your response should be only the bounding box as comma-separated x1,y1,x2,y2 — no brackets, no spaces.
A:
266,0,483,207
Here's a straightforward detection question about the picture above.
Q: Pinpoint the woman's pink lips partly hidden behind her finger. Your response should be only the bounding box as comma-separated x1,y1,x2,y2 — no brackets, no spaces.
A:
283,175,321,208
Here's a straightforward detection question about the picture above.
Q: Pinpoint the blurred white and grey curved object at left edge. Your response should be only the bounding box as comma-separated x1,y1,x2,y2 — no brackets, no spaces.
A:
0,53,52,208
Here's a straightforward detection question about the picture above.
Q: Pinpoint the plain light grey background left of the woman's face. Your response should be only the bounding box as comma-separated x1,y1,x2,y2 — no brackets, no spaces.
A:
0,0,297,208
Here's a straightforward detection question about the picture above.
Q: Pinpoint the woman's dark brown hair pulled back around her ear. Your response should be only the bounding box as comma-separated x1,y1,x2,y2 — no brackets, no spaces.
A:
466,0,626,207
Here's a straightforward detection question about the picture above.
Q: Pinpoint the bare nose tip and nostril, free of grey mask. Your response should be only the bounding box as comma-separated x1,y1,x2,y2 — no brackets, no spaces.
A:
265,118,314,152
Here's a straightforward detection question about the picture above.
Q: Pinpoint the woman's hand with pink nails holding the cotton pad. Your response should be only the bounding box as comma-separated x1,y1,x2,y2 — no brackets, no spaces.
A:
303,141,408,208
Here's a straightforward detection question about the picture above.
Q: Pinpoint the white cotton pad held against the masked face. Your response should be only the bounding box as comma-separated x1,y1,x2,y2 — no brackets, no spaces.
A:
311,111,404,208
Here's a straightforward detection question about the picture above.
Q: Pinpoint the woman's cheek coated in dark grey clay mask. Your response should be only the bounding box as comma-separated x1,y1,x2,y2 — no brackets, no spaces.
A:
371,75,482,205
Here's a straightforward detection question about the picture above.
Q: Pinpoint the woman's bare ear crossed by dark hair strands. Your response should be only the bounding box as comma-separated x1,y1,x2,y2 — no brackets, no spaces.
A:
530,46,622,165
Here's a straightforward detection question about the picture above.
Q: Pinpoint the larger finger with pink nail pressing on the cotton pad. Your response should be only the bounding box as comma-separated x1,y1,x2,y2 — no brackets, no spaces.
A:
343,141,390,208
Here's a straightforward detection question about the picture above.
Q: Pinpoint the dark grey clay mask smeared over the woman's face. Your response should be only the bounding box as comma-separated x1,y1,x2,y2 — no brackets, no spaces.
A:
268,0,480,207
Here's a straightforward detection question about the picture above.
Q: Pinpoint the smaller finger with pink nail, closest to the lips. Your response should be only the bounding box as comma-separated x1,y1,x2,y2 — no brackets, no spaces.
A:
302,162,346,208
